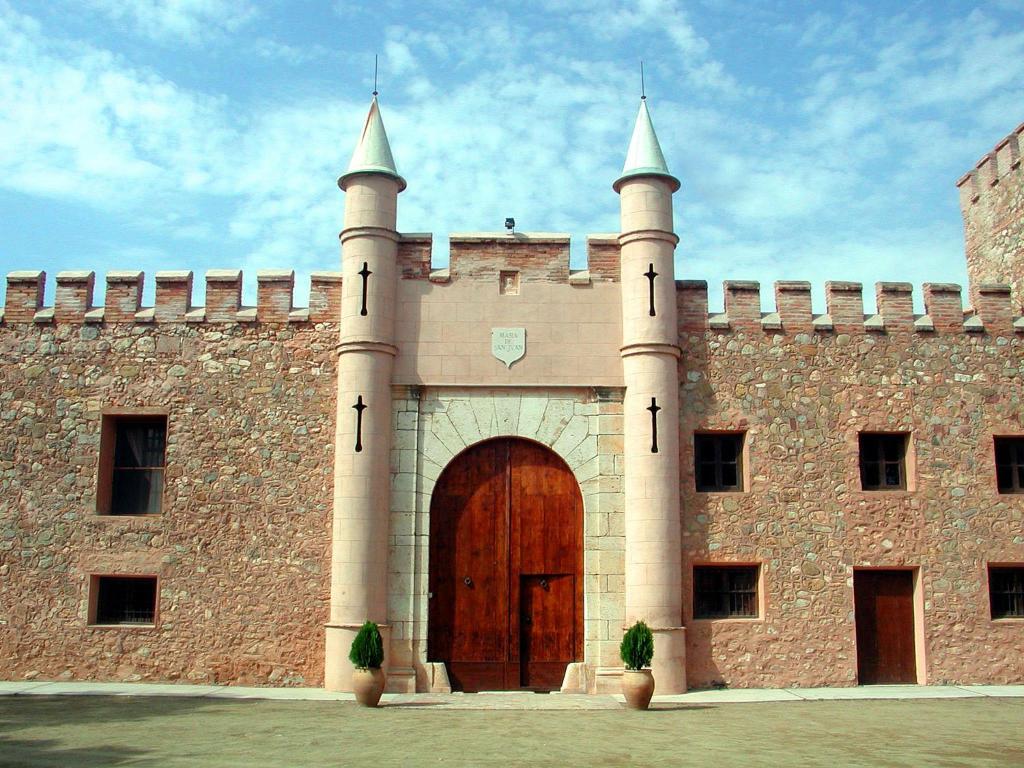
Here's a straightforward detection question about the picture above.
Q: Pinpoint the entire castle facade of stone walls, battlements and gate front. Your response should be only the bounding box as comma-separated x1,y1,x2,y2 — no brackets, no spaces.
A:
0,109,1024,691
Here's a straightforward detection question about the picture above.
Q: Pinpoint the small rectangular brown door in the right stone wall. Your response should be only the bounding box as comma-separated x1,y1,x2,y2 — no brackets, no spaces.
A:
853,570,918,685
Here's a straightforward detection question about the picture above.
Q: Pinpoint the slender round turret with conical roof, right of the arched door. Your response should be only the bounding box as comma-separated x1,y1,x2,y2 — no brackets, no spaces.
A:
612,98,686,693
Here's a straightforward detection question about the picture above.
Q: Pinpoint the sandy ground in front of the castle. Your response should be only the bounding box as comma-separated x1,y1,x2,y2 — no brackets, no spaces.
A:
0,684,1024,768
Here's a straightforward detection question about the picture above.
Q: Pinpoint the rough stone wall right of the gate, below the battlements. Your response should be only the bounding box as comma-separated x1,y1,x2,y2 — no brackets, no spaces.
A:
681,329,1024,687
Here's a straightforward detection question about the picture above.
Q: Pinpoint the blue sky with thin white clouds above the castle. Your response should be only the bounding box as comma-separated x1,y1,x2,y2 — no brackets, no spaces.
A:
0,0,1024,311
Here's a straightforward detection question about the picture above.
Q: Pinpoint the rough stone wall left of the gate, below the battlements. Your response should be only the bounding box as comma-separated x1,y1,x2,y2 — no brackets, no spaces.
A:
0,319,338,685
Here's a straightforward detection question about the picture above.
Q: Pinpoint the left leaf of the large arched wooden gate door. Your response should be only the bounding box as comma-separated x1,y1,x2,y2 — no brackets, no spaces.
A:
427,440,509,691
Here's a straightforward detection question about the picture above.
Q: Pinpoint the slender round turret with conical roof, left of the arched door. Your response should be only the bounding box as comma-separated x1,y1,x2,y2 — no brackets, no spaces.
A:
325,92,406,690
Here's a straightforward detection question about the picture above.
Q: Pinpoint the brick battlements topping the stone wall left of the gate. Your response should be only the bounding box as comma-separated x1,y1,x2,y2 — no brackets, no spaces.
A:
0,269,341,325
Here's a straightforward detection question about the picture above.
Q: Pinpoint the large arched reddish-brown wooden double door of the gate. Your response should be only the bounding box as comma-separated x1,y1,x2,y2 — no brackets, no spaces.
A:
427,438,583,691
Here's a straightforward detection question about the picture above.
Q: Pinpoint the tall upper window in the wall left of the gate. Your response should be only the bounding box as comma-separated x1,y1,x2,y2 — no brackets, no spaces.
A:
96,416,167,515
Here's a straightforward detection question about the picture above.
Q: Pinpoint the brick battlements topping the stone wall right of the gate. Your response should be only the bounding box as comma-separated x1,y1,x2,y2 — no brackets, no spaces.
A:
676,281,1024,335
